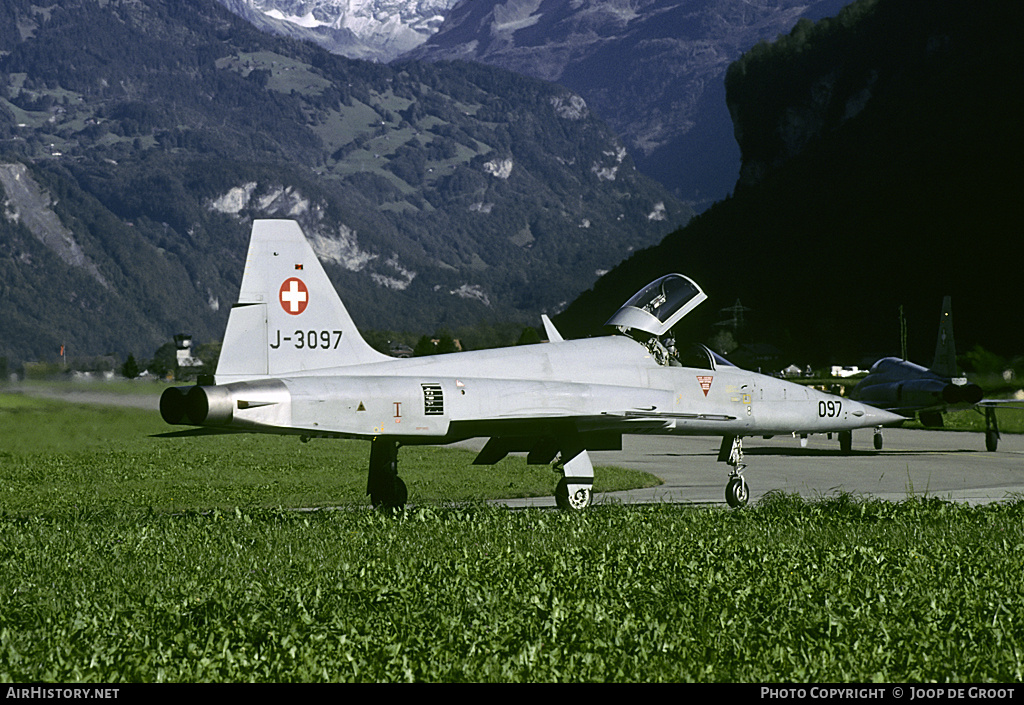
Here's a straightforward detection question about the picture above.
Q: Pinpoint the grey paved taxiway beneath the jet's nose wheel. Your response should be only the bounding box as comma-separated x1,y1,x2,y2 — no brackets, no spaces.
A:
479,428,1024,506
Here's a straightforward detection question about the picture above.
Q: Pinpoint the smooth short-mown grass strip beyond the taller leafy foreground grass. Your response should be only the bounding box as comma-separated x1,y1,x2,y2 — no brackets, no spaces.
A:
0,391,659,514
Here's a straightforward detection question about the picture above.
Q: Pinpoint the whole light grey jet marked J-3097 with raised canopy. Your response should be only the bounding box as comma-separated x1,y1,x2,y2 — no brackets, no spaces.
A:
160,220,901,508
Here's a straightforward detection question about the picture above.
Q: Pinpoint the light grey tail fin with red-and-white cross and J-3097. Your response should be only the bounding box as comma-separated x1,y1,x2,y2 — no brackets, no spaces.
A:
216,220,389,383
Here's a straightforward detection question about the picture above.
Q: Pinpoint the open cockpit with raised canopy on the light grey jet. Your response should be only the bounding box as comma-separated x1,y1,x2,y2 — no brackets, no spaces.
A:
604,275,735,370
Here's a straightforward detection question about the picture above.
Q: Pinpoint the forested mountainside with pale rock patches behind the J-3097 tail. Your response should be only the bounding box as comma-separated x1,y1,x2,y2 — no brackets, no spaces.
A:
0,0,692,362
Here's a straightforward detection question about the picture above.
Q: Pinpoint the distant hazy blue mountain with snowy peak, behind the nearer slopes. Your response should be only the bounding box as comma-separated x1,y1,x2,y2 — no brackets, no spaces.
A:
221,0,846,211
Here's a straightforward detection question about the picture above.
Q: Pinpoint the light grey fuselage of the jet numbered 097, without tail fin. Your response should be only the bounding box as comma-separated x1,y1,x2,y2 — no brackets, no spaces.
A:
161,336,899,443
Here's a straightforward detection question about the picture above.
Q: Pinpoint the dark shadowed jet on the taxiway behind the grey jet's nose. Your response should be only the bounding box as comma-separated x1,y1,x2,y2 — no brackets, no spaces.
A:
840,296,1024,452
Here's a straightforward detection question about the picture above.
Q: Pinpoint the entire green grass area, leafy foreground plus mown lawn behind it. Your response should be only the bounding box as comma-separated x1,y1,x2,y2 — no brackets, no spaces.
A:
0,395,1024,682
